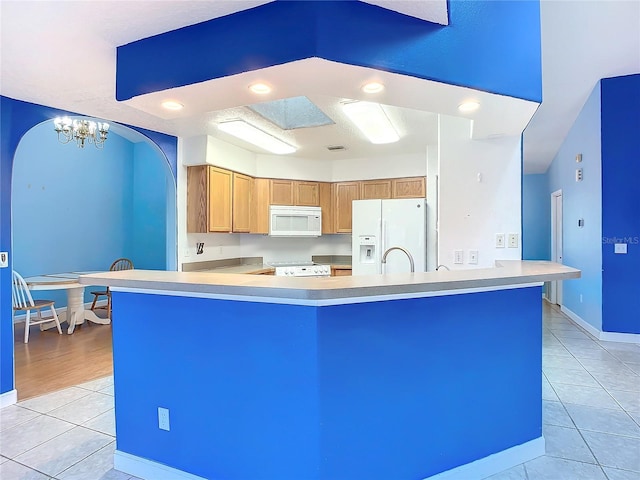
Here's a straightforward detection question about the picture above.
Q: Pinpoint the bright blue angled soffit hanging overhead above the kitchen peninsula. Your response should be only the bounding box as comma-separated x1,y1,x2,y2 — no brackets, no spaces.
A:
116,0,542,102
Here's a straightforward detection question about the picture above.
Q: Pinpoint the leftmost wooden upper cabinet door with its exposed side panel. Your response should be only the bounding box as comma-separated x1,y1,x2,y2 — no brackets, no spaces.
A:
187,165,233,233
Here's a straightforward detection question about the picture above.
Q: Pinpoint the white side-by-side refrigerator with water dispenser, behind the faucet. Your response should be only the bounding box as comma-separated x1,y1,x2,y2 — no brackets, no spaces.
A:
352,198,427,275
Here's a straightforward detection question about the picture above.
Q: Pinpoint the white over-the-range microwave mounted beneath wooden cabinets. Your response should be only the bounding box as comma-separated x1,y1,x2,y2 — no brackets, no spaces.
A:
269,205,322,237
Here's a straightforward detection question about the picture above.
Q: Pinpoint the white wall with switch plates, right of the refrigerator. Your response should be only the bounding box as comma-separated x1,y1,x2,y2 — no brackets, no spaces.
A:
438,115,522,269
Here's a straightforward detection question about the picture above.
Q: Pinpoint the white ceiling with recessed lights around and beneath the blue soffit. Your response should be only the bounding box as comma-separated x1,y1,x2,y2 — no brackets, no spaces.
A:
0,0,640,173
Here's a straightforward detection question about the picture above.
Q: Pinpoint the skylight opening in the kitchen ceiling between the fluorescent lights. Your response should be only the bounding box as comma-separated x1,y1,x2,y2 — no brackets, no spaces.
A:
248,97,335,130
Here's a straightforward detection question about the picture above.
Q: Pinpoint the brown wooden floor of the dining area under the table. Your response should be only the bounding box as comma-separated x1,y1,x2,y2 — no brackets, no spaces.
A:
14,322,113,400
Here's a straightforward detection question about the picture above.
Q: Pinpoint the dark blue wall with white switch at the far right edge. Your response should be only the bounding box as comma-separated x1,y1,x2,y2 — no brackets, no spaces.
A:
601,74,640,333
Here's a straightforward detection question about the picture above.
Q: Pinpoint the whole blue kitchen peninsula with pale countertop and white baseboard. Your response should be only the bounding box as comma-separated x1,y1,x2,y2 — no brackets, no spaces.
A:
81,261,580,480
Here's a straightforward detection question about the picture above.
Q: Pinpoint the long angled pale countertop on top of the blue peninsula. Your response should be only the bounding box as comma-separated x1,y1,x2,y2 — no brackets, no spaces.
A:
80,261,580,304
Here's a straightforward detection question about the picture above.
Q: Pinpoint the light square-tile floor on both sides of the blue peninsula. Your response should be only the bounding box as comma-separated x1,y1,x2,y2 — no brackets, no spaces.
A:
0,305,640,480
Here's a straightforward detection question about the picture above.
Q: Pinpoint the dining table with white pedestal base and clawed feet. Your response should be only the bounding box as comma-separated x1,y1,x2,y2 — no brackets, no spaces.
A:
24,271,111,335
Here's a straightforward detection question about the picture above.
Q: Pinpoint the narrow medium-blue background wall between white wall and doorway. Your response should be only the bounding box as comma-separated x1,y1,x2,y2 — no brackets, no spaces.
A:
522,174,551,260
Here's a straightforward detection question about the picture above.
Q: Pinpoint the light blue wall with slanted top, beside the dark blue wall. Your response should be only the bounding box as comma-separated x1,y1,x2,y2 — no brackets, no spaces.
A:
547,84,603,330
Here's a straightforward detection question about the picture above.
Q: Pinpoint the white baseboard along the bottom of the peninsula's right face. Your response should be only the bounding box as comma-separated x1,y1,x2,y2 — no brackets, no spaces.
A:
425,437,545,480
